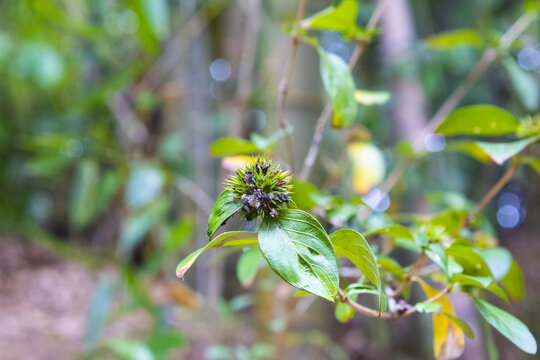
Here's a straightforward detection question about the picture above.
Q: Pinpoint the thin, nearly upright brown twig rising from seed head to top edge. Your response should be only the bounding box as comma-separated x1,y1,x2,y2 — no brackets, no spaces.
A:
276,0,306,170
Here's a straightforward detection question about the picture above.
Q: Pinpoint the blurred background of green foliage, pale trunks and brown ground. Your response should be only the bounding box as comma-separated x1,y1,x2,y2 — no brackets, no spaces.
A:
0,0,540,359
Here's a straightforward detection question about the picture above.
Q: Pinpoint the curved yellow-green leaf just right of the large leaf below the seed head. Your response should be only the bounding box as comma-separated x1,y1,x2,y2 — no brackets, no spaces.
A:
330,229,383,311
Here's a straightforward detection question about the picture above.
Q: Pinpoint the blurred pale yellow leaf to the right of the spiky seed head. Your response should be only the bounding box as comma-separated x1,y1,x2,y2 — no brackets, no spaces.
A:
347,142,385,194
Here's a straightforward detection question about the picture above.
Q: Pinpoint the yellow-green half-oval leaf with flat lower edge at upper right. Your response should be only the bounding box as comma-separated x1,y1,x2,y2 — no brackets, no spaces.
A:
436,105,519,135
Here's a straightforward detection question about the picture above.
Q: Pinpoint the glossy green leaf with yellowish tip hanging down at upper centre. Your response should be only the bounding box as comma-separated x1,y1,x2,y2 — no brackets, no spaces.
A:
318,47,358,129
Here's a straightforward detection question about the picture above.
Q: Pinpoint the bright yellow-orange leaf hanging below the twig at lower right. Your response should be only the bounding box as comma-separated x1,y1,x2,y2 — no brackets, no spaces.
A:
419,280,465,360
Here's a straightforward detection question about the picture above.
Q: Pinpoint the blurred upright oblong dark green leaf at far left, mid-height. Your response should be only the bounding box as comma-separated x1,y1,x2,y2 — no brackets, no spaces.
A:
69,159,100,229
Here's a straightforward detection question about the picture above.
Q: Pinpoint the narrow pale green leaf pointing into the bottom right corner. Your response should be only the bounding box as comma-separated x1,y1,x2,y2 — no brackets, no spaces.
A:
473,298,537,354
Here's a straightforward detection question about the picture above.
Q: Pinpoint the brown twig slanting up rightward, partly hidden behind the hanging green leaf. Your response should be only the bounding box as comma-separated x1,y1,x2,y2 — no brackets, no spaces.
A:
300,0,388,181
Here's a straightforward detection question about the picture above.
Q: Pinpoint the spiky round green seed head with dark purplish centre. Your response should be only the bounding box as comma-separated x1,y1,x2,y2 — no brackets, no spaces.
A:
226,156,292,220
